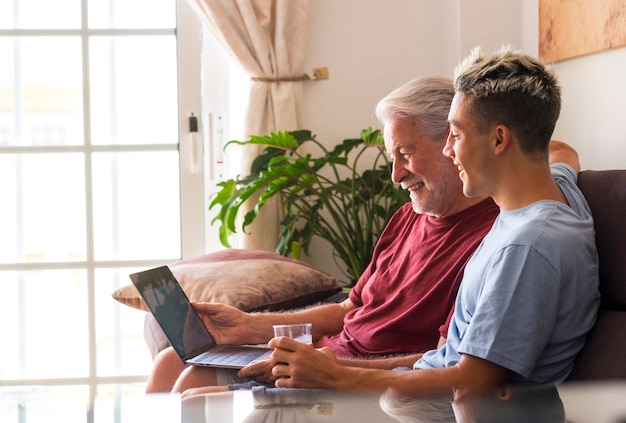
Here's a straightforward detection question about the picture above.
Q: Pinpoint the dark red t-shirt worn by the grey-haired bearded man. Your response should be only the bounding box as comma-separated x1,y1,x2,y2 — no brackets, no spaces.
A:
316,199,499,357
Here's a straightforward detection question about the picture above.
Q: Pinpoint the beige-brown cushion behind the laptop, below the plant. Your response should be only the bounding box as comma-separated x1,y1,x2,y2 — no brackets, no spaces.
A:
113,249,341,311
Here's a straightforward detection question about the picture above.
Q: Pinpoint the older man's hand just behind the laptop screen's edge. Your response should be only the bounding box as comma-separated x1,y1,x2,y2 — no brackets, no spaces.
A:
191,302,250,345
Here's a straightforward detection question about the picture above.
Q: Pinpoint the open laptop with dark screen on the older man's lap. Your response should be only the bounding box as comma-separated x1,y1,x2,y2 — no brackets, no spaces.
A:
129,266,272,369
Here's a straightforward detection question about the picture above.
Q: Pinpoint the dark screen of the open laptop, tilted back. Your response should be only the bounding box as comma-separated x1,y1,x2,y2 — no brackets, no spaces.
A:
130,266,216,361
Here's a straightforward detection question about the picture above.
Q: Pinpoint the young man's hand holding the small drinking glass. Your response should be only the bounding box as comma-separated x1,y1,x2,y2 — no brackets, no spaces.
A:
269,336,341,389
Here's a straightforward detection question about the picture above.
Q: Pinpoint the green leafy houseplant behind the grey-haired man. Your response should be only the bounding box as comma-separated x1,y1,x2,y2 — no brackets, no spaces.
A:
209,128,407,283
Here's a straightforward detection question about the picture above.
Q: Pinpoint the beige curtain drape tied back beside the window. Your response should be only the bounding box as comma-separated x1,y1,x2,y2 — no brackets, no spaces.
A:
189,0,309,251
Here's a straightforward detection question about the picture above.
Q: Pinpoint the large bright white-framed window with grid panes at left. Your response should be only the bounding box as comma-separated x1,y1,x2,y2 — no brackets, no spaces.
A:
0,0,229,423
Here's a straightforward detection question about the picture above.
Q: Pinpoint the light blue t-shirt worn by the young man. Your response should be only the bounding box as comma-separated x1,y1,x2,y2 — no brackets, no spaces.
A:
414,163,600,384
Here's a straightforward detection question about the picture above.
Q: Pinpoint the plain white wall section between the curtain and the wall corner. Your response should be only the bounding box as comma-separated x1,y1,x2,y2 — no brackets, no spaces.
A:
303,0,444,145
